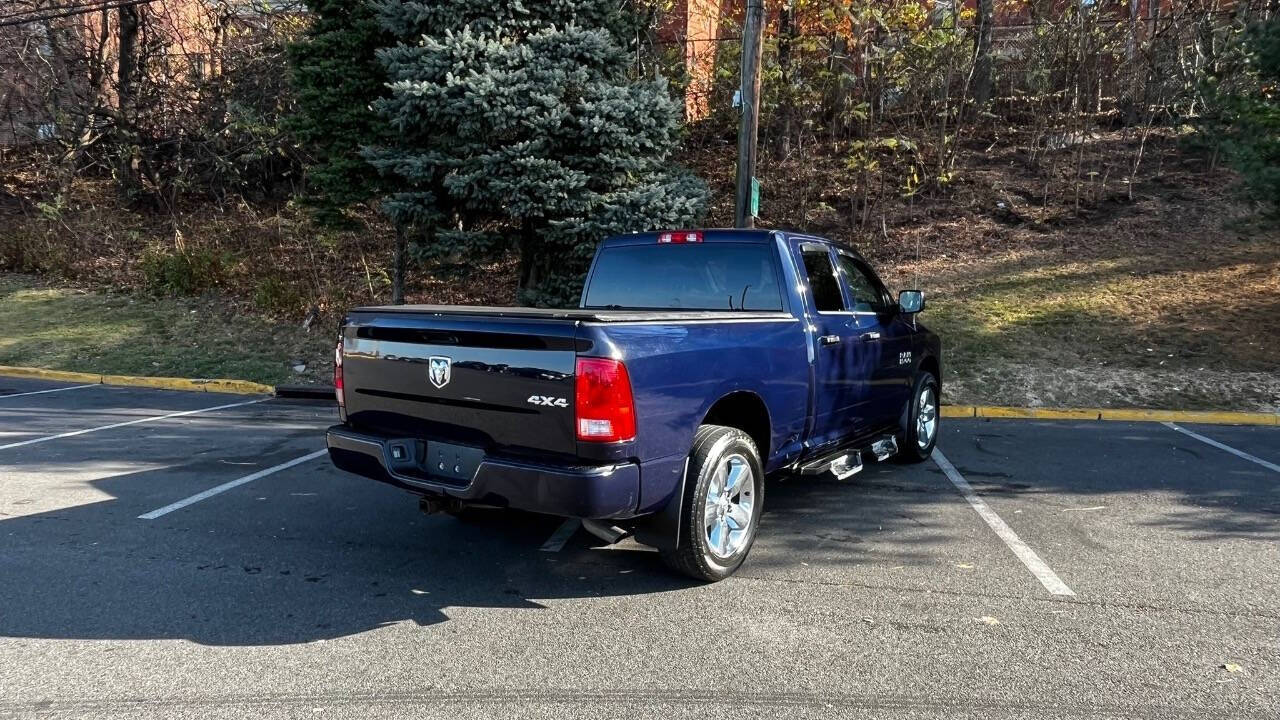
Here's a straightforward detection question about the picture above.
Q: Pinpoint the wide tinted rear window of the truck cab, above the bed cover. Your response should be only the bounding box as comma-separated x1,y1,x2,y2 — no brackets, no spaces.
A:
582,242,782,311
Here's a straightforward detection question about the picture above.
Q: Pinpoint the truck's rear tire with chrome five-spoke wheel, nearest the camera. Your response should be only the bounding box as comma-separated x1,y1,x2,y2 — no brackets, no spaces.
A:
662,425,764,583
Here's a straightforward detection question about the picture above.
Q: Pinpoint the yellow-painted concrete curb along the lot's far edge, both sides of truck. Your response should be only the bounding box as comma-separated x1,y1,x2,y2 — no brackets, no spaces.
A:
0,365,1280,427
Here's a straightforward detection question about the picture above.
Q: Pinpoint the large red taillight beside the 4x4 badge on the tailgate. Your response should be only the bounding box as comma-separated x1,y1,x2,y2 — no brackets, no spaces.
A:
573,357,636,442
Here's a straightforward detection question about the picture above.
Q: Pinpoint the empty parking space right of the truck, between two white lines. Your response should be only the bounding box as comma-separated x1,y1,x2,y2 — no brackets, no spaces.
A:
943,420,1280,611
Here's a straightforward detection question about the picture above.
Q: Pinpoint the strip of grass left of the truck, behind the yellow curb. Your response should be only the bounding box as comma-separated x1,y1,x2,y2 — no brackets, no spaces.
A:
0,274,335,384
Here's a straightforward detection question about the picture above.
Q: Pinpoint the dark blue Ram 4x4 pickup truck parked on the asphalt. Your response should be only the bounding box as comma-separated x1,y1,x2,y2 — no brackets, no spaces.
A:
328,229,942,580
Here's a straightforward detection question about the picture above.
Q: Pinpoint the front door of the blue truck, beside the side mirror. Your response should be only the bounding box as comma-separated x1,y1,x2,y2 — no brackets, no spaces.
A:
836,252,915,430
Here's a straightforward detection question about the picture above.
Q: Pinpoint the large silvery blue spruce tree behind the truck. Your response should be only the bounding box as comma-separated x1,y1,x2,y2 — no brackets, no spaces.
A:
369,0,707,305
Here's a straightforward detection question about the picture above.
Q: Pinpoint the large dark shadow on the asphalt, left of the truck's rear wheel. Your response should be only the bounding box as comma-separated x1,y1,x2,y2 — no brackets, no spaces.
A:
0,453,706,646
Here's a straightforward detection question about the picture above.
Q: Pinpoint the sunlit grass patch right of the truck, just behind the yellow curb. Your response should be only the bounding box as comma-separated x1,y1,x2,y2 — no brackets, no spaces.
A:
914,237,1280,410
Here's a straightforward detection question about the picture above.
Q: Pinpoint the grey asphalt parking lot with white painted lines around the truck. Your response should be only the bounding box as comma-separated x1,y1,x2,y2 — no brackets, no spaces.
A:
0,378,1280,719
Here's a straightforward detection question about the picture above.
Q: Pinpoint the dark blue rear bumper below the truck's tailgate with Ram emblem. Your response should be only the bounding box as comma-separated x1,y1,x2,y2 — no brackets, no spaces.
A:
326,425,640,519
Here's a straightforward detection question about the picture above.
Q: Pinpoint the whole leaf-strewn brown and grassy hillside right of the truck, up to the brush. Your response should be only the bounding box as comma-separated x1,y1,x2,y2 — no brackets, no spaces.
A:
694,126,1280,411
